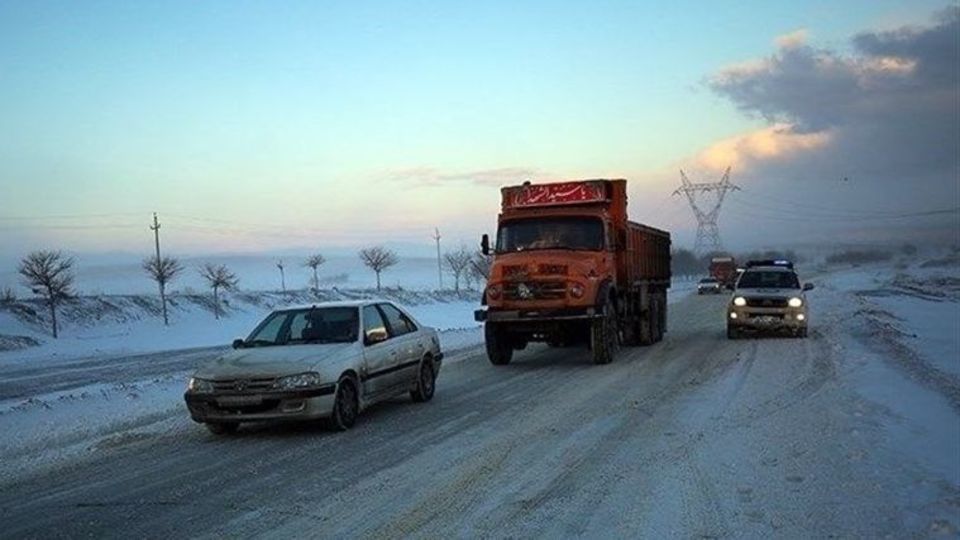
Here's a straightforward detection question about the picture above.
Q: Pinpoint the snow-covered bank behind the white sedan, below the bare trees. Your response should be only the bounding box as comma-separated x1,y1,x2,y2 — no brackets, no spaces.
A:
0,289,479,362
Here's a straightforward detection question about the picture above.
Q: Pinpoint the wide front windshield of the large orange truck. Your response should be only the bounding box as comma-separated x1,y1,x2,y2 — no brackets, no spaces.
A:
497,217,603,253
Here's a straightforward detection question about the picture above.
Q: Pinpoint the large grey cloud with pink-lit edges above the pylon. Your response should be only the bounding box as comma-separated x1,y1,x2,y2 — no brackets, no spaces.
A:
687,6,960,245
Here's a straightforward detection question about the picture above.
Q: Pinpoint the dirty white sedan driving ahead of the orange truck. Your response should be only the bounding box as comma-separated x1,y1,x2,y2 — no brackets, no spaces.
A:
184,300,443,434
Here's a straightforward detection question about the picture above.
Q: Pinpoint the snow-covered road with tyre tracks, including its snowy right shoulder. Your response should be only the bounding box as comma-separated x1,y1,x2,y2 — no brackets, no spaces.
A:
0,272,960,538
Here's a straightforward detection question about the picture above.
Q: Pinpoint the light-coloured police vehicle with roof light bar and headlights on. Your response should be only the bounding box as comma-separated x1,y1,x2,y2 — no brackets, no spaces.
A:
727,261,813,339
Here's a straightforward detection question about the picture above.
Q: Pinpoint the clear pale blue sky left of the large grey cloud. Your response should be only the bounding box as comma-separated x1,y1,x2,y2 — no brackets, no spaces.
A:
0,0,949,252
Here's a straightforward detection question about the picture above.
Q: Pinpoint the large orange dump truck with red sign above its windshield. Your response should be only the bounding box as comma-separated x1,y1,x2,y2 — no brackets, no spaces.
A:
475,180,670,365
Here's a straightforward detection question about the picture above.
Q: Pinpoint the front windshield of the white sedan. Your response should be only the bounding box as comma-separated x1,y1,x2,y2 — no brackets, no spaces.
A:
244,307,360,347
